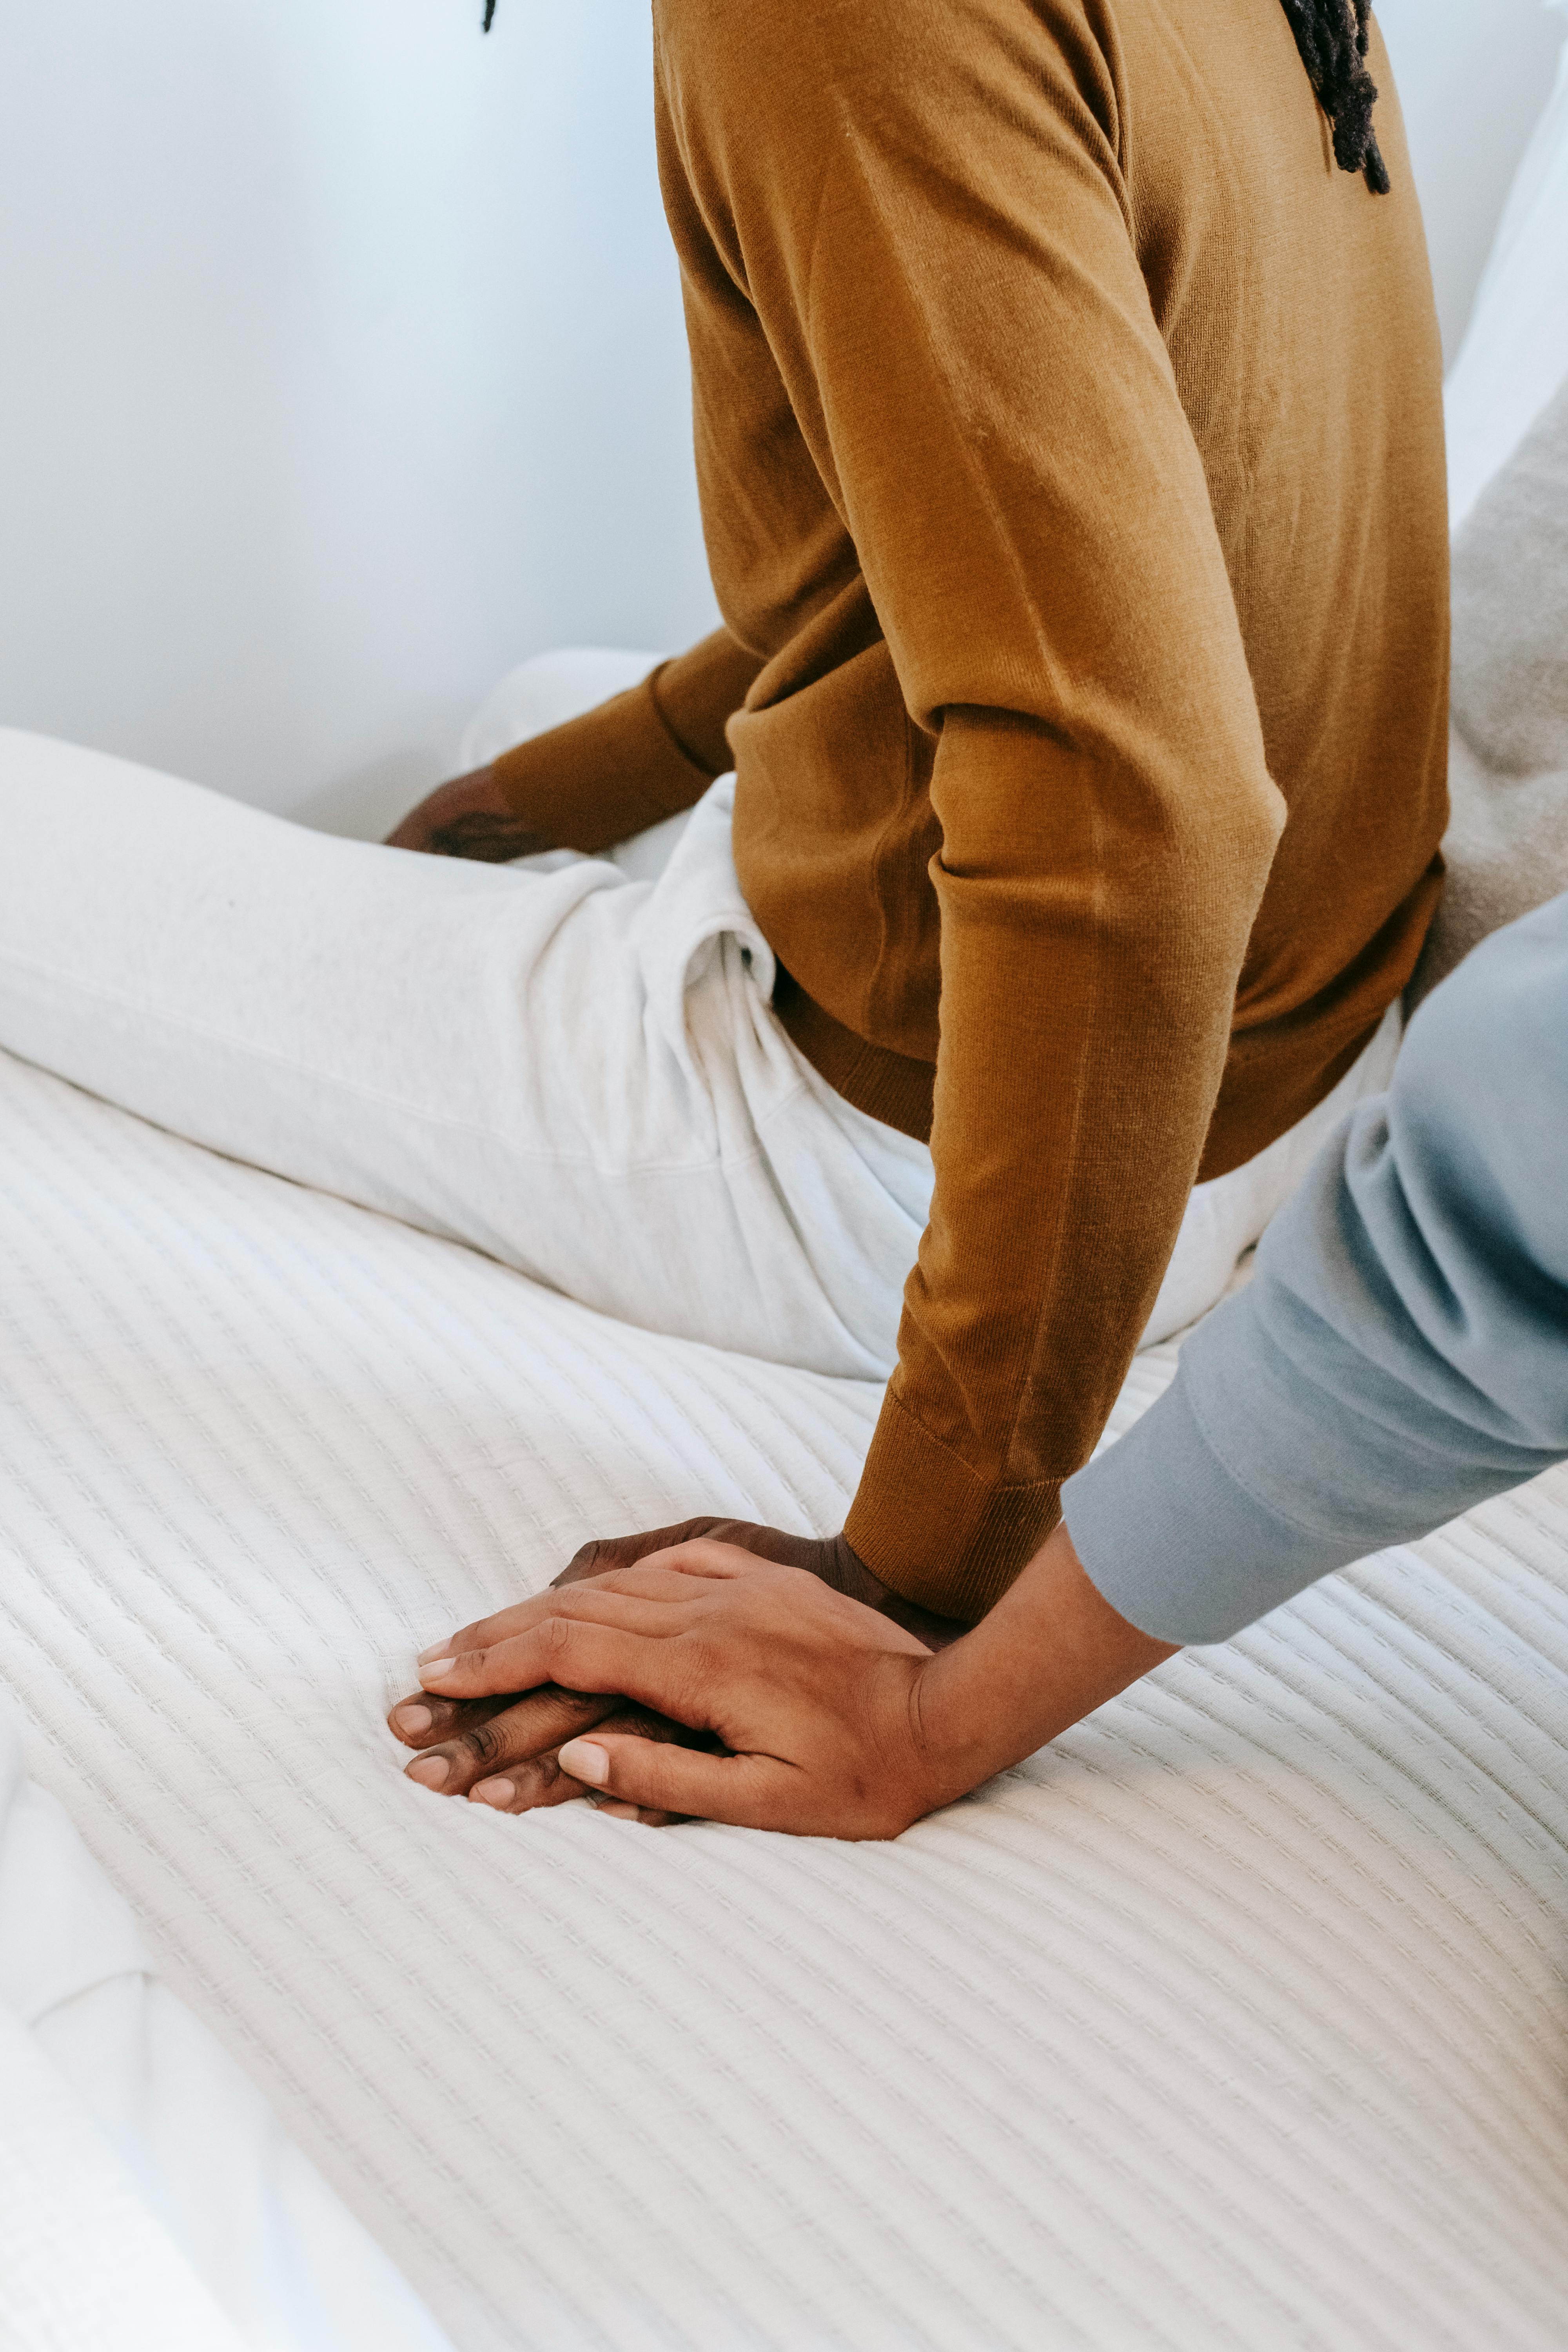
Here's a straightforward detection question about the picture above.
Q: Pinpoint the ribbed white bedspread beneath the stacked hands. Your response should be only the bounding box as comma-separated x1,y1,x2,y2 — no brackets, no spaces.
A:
0,1056,1568,2352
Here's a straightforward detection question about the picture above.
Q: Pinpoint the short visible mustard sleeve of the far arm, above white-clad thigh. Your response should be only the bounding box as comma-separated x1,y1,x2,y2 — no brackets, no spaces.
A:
494,628,762,854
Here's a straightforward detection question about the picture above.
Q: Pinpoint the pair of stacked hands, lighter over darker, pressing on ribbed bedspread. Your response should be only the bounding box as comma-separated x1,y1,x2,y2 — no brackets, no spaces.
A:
390,1519,1176,1837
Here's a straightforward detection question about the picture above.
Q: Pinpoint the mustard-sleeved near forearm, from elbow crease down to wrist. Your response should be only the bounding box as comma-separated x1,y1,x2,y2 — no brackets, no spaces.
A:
846,710,1276,1621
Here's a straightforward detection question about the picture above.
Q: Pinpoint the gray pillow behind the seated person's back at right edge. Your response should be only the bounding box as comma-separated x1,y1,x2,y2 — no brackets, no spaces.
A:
1406,383,1568,1007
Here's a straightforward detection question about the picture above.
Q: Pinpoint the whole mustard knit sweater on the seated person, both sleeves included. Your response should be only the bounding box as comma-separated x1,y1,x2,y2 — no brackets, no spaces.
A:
501,0,1448,1616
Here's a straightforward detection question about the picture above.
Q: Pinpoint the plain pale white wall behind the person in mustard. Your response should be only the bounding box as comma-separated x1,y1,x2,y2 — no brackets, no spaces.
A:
0,0,1563,833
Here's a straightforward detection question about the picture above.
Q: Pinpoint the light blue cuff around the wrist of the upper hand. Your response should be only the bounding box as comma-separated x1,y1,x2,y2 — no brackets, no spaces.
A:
1062,1374,1354,1646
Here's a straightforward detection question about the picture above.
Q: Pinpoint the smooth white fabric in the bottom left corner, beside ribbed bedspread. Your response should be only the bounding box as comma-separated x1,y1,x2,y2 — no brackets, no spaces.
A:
0,1703,446,2352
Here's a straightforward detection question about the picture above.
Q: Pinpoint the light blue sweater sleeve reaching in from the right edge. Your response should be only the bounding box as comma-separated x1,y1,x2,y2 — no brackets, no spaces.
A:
1063,896,1568,1642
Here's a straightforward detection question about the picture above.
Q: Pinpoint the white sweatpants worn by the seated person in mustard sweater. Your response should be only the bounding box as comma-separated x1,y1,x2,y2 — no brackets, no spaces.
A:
0,654,1396,1378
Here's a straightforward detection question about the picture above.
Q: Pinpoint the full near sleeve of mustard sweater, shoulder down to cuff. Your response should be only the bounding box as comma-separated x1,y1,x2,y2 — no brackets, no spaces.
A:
663,0,1283,1618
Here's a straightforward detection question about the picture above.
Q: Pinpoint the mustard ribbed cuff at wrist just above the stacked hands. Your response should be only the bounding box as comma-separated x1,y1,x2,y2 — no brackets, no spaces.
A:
844,1390,1060,1623
